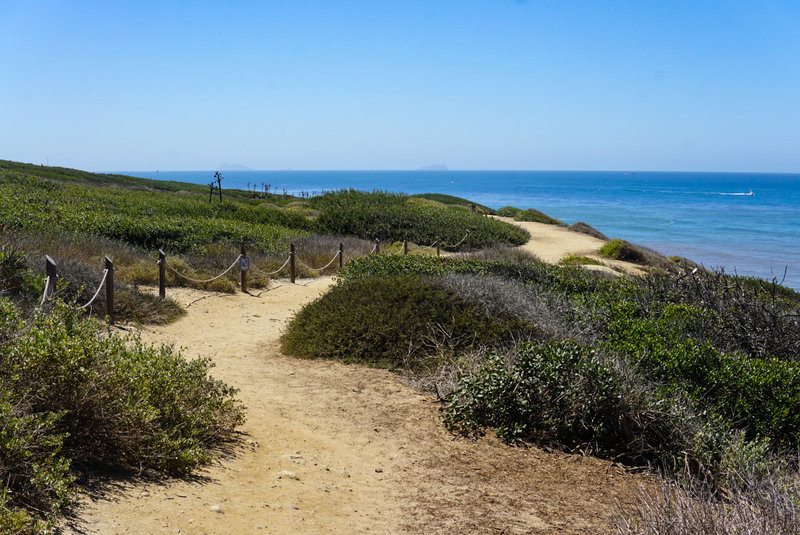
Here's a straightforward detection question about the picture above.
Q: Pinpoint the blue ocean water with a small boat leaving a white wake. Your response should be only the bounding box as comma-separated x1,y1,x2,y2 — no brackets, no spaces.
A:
126,171,800,289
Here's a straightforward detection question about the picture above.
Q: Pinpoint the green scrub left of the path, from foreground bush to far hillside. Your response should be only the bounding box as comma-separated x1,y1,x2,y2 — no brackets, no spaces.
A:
0,161,527,534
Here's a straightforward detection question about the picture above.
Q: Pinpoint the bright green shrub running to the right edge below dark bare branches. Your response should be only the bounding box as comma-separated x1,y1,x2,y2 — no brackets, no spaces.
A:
603,303,800,448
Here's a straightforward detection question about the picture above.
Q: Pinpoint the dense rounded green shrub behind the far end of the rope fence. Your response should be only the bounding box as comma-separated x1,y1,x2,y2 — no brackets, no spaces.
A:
310,189,529,248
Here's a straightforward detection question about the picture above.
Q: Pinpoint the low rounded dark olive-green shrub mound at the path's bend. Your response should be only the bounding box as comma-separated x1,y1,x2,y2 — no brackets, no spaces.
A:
282,275,525,369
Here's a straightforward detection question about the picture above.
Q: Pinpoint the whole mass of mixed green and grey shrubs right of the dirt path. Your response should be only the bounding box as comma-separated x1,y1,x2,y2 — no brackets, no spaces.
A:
283,254,800,533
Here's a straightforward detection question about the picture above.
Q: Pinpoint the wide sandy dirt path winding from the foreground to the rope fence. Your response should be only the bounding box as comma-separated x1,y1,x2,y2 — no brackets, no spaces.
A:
66,278,641,534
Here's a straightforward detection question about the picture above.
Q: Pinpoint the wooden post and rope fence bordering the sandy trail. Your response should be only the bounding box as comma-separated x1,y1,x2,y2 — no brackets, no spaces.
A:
39,230,472,325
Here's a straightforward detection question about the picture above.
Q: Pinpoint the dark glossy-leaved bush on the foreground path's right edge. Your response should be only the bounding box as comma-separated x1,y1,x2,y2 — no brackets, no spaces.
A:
444,342,684,458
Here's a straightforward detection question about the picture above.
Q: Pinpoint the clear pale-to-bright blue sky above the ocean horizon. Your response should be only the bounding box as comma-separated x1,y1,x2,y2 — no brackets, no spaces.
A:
0,0,800,172
